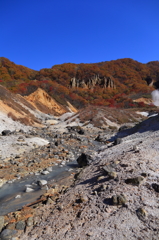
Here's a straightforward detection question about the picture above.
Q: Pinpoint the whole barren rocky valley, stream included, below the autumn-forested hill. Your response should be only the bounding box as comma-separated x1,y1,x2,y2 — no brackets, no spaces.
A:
0,87,159,240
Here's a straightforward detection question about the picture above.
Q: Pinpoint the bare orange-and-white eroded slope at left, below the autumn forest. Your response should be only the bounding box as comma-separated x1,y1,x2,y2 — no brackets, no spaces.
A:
0,86,76,130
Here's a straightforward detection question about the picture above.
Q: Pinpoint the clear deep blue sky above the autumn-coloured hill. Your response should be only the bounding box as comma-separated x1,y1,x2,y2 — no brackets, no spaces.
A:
0,0,159,70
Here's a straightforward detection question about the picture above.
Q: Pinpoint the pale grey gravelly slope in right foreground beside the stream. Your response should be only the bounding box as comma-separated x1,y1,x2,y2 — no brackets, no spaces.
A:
19,116,159,240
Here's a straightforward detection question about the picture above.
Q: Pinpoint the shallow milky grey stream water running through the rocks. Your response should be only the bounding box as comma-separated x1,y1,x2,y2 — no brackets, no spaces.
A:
0,161,77,216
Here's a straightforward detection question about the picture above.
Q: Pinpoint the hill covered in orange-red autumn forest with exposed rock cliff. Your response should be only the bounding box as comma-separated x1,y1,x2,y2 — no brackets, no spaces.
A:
0,57,159,108
